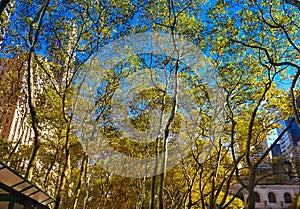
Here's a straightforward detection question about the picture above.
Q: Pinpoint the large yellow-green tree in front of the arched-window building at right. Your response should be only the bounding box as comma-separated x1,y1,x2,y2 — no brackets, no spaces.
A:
207,1,299,208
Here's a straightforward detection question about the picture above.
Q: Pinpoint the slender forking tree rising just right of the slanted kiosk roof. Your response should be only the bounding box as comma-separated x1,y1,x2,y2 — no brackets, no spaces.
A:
34,1,135,208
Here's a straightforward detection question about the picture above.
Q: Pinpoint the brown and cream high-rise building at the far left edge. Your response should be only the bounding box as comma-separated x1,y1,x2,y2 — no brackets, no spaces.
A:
0,56,33,144
